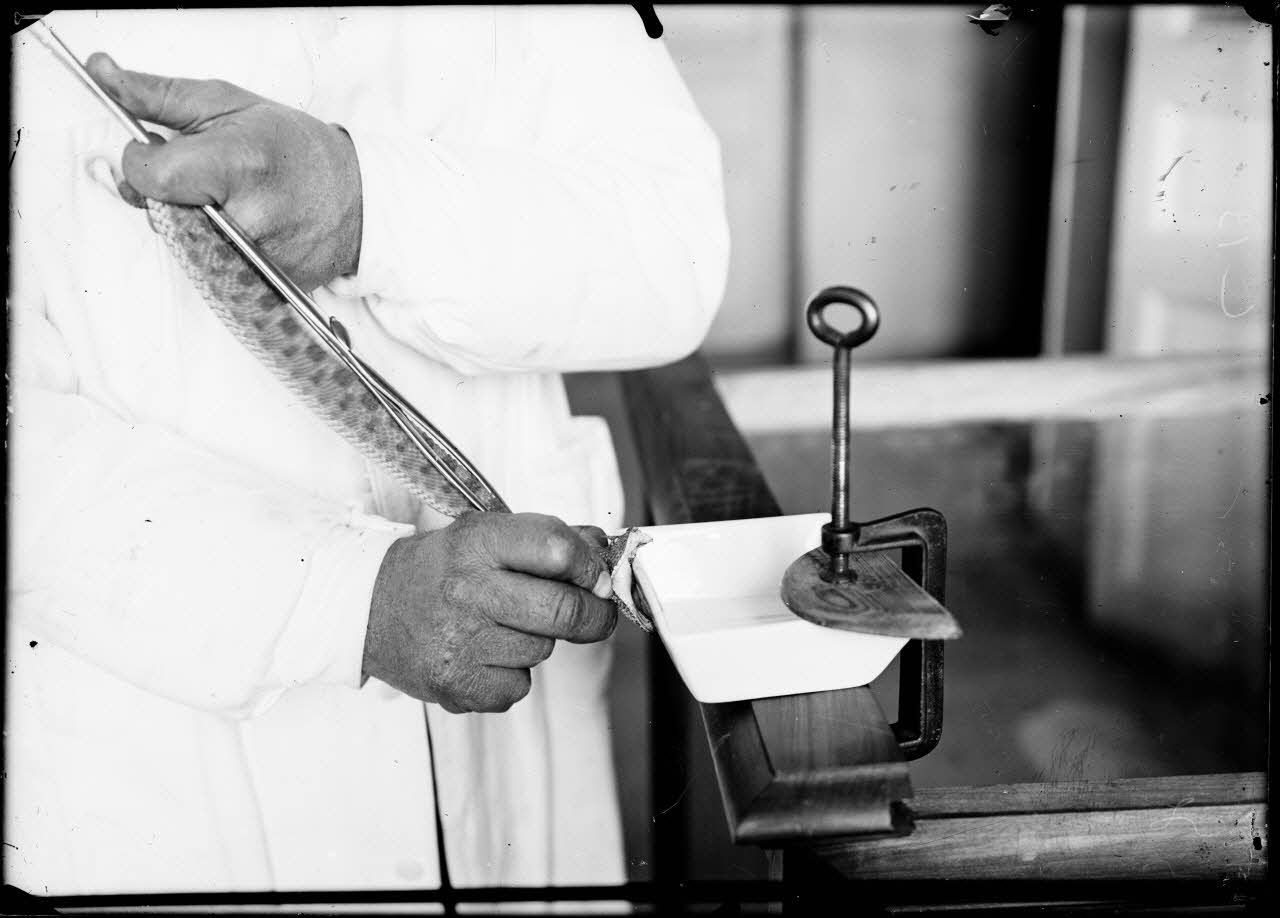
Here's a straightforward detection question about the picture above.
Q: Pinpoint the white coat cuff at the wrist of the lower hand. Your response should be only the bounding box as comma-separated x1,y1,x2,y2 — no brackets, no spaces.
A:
255,513,415,713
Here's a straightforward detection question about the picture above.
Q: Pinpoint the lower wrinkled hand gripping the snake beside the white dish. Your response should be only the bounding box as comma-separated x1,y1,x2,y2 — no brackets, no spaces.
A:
364,513,617,713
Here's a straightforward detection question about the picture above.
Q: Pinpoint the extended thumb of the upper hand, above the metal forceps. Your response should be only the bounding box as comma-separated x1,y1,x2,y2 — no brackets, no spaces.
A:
84,51,256,131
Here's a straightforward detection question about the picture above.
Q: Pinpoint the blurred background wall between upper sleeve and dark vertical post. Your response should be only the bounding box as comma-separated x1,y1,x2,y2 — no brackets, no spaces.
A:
657,5,1060,365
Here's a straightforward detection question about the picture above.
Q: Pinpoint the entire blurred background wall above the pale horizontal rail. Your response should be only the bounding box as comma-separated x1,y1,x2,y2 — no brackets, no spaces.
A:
657,4,1271,366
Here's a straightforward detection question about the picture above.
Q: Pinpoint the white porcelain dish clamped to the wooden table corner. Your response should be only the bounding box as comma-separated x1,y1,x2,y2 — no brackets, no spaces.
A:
634,513,906,704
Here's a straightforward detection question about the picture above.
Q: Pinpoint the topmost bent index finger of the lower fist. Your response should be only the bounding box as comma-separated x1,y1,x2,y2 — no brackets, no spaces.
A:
465,513,612,599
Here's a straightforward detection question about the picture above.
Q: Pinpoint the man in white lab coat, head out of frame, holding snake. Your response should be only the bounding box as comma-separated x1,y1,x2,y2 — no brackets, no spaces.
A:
4,6,728,894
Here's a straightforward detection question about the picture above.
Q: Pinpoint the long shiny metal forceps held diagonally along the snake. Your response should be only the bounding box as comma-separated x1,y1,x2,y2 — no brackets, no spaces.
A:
31,20,511,513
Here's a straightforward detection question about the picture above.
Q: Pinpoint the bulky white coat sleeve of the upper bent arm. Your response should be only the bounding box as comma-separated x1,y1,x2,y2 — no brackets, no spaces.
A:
334,6,728,373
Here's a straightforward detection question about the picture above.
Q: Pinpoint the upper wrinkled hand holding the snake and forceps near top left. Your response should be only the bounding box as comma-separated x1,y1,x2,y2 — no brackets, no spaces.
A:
86,54,362,291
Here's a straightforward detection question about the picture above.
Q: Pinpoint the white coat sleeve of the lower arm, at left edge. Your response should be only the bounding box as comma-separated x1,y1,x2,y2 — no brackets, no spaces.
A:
8,257,407,717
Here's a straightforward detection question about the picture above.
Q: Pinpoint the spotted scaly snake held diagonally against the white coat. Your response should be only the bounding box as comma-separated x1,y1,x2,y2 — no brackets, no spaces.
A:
138,198,653,631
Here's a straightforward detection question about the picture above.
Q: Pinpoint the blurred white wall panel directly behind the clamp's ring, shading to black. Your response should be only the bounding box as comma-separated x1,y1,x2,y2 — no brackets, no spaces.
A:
801,5,1039,357
